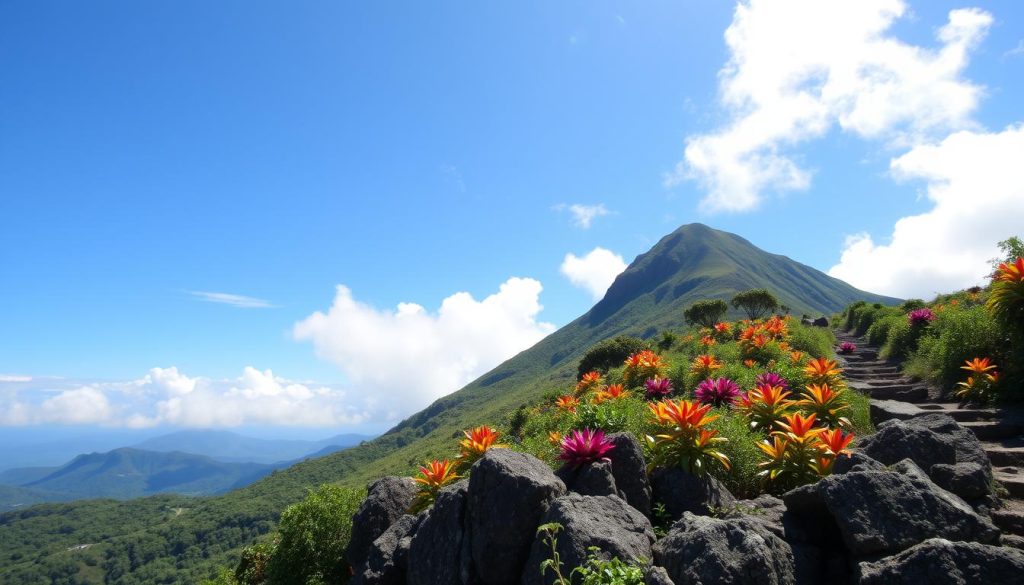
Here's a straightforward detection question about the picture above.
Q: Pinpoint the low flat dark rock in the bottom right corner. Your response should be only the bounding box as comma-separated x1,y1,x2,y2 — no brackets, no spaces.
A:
860,538,1024,585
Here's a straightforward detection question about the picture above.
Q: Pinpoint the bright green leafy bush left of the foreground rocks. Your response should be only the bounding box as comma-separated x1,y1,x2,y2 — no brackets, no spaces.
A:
266,484,364,585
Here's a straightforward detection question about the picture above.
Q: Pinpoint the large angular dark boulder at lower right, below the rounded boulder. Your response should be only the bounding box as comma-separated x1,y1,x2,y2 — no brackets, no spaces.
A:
815,471,999,556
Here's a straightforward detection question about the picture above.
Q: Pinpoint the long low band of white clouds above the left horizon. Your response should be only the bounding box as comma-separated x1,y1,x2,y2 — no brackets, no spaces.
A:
0,367,370,428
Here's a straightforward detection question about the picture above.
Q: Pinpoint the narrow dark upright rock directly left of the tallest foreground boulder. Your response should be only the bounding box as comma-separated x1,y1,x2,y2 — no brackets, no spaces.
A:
407,479,470,585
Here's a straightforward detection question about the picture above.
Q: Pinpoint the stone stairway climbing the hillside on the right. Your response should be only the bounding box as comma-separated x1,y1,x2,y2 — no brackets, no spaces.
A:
836,331,1024,509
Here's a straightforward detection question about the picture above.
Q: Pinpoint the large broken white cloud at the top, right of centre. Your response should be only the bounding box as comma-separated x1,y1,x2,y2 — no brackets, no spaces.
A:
666,0,992,211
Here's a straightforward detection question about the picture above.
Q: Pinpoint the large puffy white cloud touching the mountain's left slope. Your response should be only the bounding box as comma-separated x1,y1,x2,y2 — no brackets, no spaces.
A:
294,278,555,416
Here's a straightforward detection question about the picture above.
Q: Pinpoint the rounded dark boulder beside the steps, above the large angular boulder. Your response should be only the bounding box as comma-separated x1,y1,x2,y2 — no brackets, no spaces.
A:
859,420,956,472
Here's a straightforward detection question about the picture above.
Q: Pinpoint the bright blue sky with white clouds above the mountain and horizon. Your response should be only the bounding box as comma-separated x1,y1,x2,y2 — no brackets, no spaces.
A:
0,0,1024,428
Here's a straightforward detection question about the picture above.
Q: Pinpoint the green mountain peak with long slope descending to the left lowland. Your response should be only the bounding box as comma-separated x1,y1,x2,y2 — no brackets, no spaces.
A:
0,224,896,583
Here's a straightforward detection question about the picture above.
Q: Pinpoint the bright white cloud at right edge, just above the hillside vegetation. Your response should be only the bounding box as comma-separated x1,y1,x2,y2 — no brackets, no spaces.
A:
828,126,1024,298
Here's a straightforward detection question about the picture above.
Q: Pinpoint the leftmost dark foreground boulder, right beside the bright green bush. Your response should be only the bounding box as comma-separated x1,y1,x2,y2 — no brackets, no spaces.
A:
345,476,416,567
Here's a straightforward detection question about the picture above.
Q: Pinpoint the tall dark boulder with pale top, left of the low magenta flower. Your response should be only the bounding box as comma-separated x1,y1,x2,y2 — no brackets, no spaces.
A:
466,449,565,585
